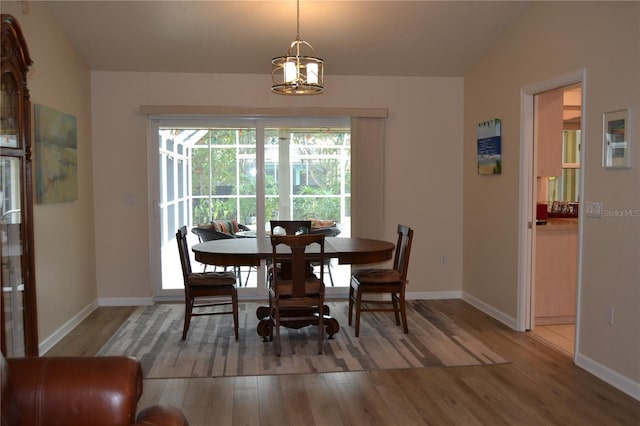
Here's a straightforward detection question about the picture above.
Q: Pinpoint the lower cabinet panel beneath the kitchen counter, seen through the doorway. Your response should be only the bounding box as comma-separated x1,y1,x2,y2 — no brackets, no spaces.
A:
535,219,578,325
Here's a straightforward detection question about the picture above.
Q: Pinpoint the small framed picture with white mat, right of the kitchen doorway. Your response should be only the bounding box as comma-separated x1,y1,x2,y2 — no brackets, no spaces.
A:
602,108,631,169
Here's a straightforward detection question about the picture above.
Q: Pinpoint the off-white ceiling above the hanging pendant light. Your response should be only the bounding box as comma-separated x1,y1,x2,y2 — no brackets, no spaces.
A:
47,0,530,76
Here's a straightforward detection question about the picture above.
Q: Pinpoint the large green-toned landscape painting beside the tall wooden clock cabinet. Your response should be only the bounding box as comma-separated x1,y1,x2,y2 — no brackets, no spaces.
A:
34,105,78,204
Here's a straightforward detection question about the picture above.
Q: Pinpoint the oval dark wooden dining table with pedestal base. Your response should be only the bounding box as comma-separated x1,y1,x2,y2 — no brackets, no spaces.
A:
191,237,395,341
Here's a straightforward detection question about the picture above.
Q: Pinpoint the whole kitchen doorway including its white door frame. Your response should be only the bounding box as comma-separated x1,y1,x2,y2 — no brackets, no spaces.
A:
518,70,585,358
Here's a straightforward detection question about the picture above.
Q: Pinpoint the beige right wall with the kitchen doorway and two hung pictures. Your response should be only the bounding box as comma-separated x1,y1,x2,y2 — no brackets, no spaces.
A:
463,2,640,398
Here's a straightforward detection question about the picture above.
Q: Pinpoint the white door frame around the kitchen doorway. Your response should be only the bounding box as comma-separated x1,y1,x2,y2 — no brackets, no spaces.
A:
516,68,587,359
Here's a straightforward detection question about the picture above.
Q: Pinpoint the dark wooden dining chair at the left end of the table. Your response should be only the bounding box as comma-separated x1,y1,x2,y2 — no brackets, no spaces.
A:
176,226,238,340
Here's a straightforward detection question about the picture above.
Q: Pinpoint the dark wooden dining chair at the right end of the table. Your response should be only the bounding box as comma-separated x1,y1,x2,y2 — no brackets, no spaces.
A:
349,225,413,337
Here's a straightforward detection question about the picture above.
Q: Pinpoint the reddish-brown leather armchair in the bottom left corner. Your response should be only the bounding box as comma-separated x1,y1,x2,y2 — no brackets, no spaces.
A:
0,355,188,426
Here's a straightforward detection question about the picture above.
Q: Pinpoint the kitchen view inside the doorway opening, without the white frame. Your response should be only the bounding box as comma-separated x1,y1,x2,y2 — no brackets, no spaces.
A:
532,84,582,355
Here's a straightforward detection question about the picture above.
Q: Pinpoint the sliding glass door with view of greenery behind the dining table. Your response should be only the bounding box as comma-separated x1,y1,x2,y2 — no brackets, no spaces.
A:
150,115,351,299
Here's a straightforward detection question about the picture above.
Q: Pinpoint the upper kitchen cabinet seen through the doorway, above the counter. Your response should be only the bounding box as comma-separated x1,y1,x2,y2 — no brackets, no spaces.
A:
534,89,564,176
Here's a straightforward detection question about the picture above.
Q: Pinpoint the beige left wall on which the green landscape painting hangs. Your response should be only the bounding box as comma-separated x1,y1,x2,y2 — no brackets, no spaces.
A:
0,1,96,349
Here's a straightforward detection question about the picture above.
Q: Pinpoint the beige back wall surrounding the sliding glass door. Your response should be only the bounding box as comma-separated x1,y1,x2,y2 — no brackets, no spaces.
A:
91,72,462,300
